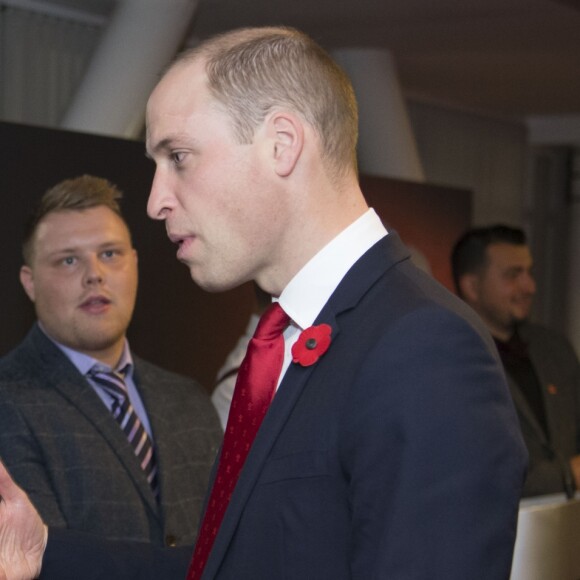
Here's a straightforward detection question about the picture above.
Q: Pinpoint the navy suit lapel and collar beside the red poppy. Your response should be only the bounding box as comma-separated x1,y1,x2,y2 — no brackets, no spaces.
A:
203,232,409,578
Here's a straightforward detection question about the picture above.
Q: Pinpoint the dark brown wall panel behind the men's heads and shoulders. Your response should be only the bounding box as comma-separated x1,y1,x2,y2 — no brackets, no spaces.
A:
0,123,471,389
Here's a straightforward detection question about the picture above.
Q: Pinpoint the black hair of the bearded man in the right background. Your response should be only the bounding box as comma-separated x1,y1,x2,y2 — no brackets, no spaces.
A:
451,224,527,295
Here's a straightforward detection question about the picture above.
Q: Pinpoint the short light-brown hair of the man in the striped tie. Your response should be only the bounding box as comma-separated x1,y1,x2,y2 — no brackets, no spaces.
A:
22,175,127,265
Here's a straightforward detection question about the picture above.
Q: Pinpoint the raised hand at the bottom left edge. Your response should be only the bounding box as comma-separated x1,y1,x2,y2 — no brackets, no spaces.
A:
0,462,48,580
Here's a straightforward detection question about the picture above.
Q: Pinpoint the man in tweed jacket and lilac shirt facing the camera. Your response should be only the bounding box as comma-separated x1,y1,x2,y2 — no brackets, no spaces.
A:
0,176,221,546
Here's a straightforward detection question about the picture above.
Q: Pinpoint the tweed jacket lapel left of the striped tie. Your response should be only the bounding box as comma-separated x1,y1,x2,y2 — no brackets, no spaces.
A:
28,326,158,514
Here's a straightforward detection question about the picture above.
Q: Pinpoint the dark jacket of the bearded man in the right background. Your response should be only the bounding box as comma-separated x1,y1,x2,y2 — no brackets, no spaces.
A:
508,324,580,496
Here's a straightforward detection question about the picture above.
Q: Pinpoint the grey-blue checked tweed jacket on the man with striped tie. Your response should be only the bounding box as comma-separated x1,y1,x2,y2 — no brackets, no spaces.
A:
0,325,221,545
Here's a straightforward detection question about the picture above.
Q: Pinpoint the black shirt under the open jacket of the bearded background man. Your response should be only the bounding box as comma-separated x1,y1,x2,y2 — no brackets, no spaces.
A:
494,330,550,440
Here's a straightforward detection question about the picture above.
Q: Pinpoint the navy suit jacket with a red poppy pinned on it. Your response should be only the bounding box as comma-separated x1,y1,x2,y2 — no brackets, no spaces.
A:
36,234,526,580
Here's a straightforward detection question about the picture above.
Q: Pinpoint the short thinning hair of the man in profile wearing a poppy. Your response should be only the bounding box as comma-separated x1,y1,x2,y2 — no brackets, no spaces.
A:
172,27,358,175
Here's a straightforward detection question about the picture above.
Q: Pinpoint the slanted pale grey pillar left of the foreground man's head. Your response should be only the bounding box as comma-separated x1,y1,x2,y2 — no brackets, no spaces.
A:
62,0,198,138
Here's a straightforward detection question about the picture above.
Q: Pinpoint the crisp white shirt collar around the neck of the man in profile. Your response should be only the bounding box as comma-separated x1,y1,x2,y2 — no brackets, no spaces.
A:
279,209,388,329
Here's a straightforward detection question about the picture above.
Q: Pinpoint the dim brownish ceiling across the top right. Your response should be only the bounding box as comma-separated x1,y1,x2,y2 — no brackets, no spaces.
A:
38,0,580,118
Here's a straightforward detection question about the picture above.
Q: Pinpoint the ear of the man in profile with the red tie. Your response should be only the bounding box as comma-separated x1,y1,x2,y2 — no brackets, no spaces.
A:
268,111,304,177
